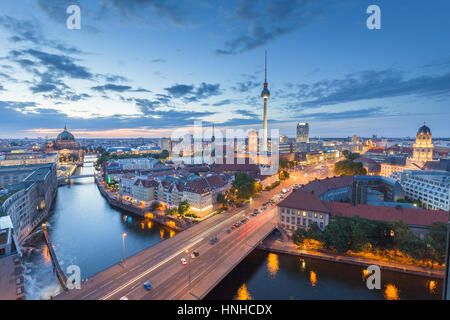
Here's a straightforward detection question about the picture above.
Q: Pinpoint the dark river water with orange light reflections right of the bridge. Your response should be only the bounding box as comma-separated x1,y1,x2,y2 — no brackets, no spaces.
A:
206,250,442,300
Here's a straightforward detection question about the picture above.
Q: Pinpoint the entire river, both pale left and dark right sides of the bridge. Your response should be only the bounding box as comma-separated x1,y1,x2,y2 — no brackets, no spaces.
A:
24,158,442,300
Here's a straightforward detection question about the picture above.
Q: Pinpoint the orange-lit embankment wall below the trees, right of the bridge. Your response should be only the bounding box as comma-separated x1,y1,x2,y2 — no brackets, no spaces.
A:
257,236,444,279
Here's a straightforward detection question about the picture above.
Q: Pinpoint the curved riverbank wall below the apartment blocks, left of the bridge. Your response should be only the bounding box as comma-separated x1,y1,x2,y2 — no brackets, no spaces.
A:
95,178,188,231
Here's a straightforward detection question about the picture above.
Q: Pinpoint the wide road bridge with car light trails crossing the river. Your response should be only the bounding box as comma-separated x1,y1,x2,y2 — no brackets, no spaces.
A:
55,207,276,300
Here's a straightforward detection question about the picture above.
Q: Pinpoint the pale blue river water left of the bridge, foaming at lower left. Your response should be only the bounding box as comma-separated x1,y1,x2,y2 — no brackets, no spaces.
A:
24,158,175,299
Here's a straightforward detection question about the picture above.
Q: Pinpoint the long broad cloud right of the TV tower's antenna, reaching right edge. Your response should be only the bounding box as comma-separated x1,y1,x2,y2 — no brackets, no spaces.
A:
294,70,450,108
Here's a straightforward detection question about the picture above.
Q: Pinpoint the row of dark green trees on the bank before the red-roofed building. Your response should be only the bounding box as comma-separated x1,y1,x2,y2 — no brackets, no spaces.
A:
293,216,447,264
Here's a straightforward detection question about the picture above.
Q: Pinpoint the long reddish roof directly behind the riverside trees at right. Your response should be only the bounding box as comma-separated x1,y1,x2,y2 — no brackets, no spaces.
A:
324,202,448,226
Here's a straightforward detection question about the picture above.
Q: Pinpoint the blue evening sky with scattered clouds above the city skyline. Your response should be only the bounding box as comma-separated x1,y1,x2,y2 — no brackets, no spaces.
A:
0,0,450,138
